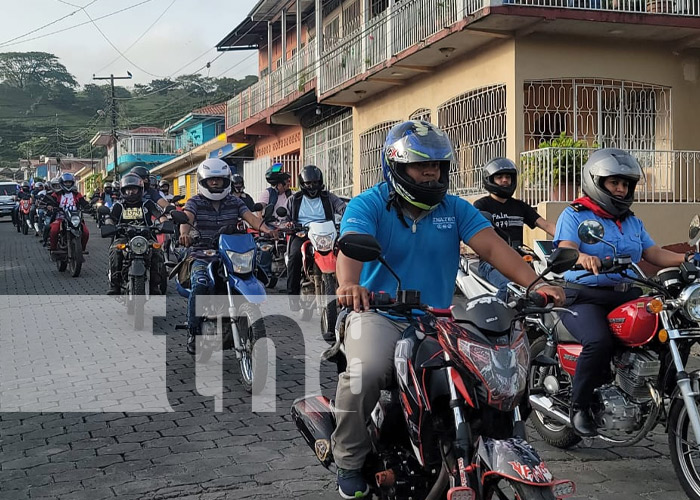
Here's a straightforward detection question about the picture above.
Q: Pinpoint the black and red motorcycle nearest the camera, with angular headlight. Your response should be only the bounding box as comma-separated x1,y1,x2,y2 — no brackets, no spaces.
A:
291,234,578,500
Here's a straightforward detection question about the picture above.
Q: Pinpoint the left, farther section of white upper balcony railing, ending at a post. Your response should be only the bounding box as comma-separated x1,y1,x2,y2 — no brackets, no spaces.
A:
226,41,317,128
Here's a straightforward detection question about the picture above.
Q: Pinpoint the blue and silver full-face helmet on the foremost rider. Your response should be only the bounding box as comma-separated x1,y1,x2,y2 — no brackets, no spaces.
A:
382,120,455,210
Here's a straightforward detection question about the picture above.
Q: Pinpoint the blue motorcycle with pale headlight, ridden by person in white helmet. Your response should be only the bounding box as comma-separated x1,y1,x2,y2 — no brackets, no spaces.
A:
170,211,266,392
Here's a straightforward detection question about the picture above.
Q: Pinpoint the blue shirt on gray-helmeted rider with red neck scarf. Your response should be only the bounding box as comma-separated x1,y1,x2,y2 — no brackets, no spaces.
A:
554,207,655,286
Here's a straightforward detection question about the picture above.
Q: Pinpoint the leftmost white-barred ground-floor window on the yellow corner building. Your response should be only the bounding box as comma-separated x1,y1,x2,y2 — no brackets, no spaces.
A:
303,110,353,197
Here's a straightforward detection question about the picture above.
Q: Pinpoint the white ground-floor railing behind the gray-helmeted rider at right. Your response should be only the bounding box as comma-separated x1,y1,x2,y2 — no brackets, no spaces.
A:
518,148,700,205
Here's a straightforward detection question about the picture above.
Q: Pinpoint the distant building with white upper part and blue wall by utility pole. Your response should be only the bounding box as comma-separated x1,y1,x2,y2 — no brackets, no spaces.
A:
90,127,177,182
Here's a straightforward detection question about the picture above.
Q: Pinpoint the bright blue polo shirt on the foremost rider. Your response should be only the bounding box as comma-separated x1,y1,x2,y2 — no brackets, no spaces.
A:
340,182,491,308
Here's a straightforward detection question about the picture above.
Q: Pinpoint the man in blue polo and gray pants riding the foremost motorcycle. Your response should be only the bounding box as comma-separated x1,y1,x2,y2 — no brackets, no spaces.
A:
332,121,564,498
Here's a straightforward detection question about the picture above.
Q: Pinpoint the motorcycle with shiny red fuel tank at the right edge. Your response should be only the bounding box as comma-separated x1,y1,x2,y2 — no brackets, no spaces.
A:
530,216,700,500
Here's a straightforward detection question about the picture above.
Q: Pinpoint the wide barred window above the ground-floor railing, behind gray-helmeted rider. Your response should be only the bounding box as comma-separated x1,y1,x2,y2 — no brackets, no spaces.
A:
524,78,673,151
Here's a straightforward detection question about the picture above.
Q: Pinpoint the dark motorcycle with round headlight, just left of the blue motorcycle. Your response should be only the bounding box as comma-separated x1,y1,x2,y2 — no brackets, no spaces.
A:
99,206,174,330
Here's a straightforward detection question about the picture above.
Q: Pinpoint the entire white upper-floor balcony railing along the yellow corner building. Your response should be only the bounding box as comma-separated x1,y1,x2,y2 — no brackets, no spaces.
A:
226,0,700,128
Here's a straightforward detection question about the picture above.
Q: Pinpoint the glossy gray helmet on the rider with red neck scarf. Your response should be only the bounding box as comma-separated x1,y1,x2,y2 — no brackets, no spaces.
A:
581,148,644,217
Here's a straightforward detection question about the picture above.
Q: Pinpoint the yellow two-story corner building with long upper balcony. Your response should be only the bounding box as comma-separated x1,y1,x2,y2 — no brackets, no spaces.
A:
219,0,700,242
